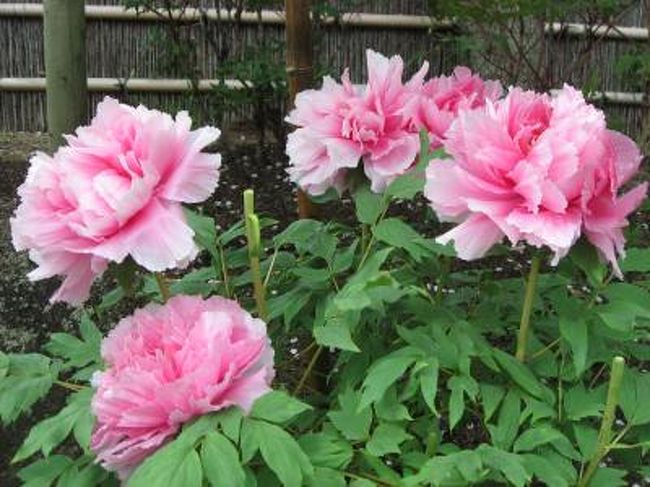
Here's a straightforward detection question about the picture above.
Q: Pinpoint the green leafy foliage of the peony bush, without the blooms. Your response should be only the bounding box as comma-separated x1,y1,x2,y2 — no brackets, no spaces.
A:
6,146,650,487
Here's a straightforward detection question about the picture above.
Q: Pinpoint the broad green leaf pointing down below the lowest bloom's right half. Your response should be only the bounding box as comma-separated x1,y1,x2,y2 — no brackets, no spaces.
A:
201,431,246,487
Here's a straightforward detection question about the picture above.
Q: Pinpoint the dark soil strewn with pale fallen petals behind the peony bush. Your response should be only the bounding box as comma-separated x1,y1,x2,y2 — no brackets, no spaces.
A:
0,127,650,487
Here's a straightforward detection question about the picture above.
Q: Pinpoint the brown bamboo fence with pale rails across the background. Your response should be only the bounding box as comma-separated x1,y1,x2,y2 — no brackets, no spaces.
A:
0,0,649,135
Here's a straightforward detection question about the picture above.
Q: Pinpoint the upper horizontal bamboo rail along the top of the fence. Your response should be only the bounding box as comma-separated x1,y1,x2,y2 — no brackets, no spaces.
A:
0,3,650,41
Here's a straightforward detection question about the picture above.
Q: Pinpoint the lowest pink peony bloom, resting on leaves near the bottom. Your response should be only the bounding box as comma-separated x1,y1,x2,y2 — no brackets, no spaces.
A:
91,296,274,479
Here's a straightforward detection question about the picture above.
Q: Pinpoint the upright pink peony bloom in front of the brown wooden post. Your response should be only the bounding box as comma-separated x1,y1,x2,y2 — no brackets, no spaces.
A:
287,50,428,195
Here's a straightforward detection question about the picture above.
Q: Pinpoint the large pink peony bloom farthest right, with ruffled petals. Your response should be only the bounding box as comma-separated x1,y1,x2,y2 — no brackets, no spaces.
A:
425,86,647,276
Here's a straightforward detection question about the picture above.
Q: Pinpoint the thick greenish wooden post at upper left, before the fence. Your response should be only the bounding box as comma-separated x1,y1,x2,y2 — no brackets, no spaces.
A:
43,0,88,142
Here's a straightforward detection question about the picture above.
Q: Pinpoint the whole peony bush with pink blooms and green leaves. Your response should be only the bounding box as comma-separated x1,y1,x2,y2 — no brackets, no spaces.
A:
0,51,650,487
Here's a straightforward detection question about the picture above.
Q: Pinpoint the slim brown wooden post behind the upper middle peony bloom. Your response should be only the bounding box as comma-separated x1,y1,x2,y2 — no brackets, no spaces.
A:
284,0,314,218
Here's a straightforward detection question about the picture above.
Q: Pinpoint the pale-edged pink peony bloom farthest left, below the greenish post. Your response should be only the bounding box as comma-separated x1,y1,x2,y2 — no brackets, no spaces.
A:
11,98,221,304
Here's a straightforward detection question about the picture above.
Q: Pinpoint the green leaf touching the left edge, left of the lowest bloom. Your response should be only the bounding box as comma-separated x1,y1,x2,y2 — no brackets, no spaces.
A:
0,354,58,424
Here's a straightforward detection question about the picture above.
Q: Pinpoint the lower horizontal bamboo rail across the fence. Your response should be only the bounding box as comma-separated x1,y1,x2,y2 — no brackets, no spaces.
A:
0,78,650,105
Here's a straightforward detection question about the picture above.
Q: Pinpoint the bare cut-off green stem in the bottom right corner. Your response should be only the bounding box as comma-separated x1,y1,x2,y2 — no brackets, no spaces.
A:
578,357,625,487
